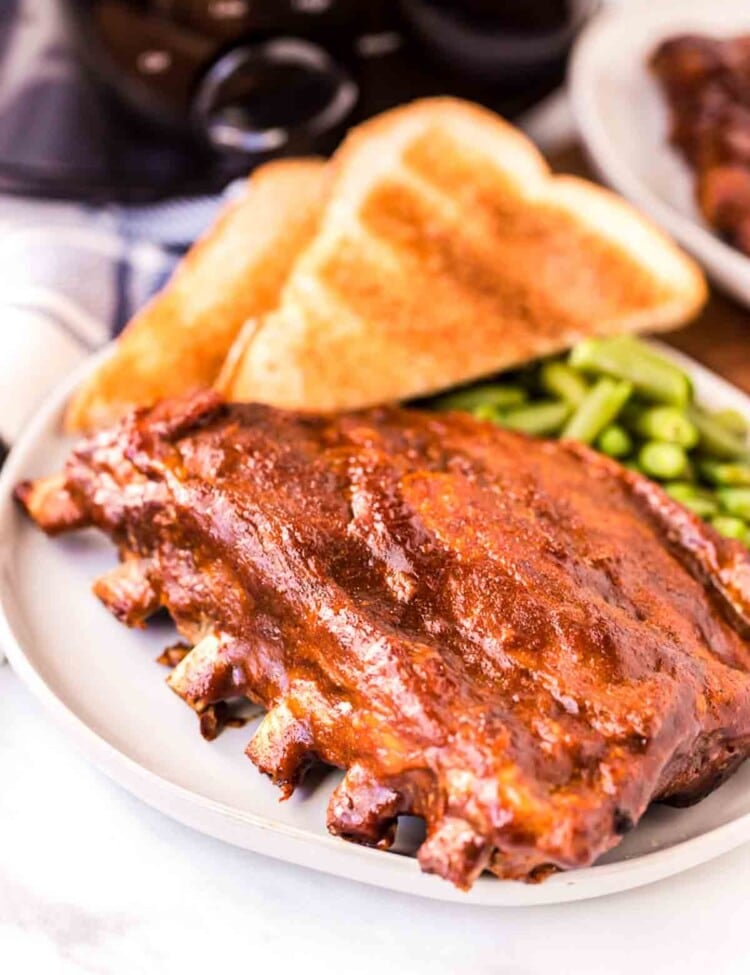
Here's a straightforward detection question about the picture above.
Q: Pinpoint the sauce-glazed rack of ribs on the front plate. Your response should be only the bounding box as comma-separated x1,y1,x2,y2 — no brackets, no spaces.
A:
17,393,750,888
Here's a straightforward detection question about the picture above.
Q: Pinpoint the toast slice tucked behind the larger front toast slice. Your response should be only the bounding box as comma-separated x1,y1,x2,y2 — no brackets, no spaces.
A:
66,158,325,430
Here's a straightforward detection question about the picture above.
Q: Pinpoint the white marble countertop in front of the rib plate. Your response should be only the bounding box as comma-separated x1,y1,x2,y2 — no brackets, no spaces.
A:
0,666,750,975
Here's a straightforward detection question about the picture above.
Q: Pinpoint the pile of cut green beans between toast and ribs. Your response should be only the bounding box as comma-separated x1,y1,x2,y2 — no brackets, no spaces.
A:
428,336,750,547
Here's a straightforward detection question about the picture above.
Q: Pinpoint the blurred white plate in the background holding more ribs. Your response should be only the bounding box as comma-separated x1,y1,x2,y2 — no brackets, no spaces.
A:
569,0,750,305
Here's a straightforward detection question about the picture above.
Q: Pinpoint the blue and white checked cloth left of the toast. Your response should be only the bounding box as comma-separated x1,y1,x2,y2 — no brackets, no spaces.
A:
0,187,231,444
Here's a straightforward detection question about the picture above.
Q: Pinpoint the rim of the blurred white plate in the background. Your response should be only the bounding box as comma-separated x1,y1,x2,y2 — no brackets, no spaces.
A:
567,0,750,306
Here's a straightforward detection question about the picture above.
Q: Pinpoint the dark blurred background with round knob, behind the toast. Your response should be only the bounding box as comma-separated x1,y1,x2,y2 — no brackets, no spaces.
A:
0,0,596,202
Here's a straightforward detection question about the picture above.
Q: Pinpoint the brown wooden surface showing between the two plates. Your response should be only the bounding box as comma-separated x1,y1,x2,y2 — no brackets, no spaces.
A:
551,146,750,393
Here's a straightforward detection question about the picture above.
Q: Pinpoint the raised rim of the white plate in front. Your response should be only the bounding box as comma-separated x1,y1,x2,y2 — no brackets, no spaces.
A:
0,342,750,907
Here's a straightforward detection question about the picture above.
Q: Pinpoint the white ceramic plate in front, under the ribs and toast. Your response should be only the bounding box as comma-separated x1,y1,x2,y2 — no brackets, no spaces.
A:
0,353,750,905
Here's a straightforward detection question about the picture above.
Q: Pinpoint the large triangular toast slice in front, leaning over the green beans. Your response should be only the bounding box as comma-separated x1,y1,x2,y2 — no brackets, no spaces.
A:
218,98,706,410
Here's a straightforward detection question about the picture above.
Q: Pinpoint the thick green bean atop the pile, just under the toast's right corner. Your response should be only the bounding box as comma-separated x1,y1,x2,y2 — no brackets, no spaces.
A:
568,335,691,406
